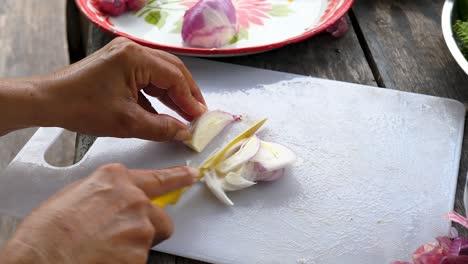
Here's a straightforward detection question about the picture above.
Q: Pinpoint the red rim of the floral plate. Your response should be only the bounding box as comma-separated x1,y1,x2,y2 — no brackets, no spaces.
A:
75,0,355,56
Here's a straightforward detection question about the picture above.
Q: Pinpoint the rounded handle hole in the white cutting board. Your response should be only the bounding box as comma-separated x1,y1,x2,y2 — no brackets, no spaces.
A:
44,130,76,167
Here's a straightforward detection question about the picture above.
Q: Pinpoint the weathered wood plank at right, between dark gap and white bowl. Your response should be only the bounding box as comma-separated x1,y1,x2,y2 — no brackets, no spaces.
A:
353,0,468,236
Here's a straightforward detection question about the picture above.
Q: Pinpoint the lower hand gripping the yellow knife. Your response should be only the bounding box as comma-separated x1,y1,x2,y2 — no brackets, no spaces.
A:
0,164,198,264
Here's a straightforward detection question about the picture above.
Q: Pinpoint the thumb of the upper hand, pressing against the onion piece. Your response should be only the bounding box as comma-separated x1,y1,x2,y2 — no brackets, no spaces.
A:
132,106,191,141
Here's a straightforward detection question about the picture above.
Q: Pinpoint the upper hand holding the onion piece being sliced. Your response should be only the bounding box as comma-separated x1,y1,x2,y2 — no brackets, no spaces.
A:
36,38,207,141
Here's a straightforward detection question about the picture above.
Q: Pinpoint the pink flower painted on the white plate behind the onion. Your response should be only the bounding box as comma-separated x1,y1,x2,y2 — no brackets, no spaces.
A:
182,0,272,29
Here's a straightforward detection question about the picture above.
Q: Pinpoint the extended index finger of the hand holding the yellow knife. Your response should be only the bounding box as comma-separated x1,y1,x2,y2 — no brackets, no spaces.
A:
129,166,199,199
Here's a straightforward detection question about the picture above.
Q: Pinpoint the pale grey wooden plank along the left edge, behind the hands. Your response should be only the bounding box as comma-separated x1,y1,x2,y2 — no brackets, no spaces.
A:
0,0,69,247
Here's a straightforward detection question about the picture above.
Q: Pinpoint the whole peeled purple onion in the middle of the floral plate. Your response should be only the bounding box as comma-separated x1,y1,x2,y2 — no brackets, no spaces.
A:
182,0,238,48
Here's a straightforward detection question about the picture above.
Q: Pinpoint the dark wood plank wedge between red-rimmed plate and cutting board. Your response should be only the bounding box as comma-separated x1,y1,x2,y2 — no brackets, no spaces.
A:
218,16,376,86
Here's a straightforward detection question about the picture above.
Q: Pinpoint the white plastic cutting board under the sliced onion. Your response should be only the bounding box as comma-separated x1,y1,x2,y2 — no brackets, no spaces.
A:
0,59,465,264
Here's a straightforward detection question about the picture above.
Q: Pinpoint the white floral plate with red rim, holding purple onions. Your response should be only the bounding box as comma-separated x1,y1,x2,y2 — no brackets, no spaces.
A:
76,0,354,56
